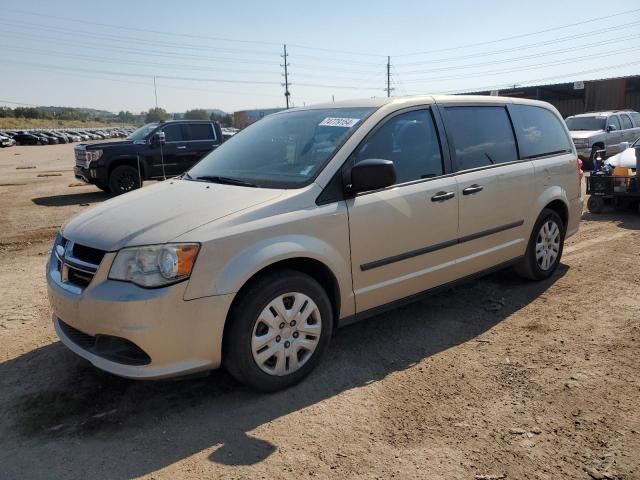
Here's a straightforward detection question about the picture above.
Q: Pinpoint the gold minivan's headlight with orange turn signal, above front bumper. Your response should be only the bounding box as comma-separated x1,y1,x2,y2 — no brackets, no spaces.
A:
109,243,200,287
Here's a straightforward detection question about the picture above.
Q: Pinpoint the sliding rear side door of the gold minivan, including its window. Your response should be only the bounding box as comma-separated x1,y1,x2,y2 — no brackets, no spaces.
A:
442,104,534,276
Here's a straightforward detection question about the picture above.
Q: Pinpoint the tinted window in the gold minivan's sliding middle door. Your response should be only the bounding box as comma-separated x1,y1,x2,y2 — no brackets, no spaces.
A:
445,107,518,170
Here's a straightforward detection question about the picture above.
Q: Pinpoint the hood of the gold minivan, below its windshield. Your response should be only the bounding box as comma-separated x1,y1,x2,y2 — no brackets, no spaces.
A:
62,179,283,251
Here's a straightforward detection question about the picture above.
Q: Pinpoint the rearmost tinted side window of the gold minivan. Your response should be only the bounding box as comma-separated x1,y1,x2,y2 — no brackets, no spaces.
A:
512,105,572,159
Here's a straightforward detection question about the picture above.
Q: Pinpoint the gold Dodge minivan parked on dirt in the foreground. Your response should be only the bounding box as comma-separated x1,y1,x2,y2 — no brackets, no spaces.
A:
47,96,582,391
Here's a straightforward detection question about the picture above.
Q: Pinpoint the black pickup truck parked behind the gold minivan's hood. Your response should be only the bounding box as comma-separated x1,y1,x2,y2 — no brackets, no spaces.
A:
73,120,223,195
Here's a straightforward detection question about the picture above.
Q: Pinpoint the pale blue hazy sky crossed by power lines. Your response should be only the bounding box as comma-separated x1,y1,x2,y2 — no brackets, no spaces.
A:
0,0,640,112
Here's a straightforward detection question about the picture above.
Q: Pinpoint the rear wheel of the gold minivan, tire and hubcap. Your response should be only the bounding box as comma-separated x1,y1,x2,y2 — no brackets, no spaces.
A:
515,208,565,280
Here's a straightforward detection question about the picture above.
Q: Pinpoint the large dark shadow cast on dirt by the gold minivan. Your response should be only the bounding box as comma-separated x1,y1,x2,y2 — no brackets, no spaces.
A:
0,265,568,478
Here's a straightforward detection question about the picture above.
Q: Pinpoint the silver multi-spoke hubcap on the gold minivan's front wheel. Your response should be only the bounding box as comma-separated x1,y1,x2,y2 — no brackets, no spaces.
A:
251,292,322,376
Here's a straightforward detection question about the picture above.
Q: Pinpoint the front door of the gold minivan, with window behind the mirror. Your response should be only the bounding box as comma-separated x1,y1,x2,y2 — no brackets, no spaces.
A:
347,107,458,313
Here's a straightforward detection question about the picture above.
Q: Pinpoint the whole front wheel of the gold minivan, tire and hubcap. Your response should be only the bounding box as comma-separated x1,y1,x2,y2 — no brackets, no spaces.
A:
222,270,333,392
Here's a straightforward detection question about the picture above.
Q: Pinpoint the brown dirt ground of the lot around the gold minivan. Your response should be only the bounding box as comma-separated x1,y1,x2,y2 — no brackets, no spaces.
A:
0,145,640,480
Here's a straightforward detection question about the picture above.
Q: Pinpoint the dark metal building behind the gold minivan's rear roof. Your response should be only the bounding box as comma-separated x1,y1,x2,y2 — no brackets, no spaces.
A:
465,75,640,117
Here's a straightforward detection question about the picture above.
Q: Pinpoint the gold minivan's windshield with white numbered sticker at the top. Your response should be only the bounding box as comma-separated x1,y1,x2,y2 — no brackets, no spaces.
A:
189,108,374,188
